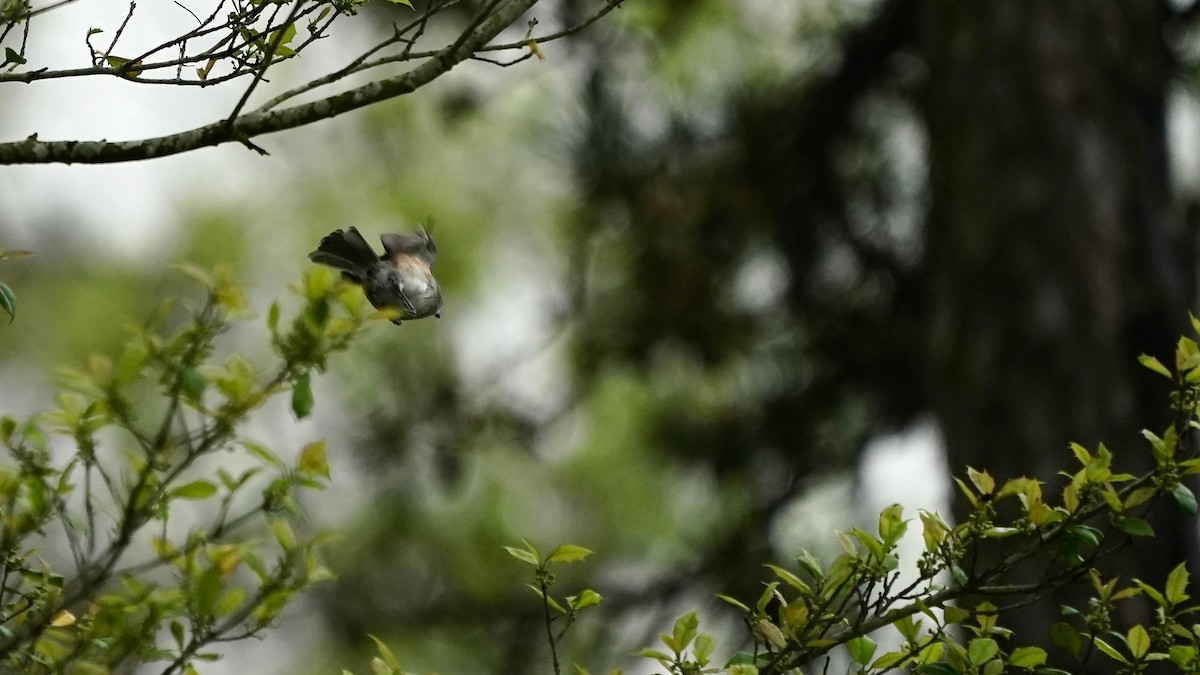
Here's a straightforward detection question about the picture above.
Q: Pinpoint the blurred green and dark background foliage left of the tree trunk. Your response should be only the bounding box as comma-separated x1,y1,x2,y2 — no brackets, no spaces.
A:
0,0,1200,674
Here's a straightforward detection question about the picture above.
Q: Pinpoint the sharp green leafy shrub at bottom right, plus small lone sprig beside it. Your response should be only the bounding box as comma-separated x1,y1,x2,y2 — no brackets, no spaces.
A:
484,318,1200,675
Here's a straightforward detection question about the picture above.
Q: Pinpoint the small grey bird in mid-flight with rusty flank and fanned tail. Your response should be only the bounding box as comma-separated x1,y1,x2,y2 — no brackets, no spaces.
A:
308,227,442,325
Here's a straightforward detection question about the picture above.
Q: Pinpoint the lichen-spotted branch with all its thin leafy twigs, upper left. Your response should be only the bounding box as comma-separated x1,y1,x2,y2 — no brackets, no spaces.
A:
0,0,623,165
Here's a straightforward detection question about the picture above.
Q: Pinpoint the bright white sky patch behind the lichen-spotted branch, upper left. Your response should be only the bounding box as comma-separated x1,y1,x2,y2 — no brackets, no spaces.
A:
0,1,384,258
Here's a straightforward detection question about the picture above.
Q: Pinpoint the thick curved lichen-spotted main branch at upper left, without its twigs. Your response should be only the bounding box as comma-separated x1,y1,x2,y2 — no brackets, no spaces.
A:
0,0,538,165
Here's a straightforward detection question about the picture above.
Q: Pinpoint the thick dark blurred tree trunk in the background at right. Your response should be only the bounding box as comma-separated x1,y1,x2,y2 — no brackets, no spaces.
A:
917,0,1195,653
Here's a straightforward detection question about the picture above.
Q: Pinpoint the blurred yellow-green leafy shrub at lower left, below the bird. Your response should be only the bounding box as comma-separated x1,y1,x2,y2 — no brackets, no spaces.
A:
0,265,368,674
